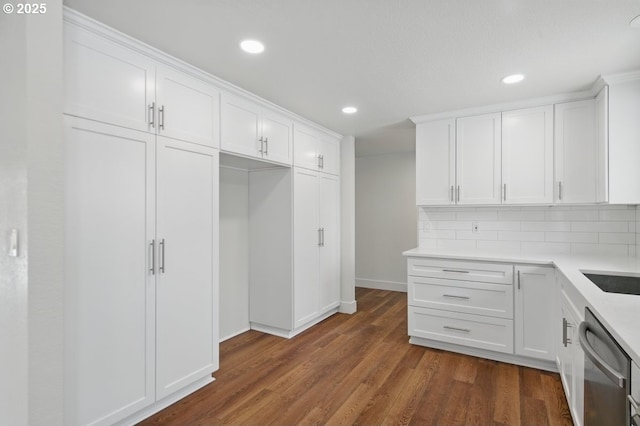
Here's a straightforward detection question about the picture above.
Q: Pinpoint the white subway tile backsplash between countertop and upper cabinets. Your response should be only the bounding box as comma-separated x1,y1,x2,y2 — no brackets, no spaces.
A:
418,205,640,256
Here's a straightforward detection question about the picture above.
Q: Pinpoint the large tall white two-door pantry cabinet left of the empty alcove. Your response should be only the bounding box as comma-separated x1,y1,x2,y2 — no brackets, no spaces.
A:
64,117,218,425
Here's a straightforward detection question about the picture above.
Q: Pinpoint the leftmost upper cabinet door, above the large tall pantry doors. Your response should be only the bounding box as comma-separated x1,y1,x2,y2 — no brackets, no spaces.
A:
64,25,155,131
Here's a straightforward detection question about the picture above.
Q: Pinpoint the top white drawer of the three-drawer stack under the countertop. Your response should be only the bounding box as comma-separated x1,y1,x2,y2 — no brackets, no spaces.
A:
407,257,513,284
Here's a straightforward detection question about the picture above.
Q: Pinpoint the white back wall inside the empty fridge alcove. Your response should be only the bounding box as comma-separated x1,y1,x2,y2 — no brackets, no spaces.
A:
220,167,249,340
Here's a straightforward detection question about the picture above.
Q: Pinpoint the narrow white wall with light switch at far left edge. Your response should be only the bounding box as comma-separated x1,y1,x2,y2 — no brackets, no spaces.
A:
0,10,28,426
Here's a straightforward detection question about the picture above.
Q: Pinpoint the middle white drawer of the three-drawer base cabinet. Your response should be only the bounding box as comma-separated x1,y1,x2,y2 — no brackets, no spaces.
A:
408,276,513,319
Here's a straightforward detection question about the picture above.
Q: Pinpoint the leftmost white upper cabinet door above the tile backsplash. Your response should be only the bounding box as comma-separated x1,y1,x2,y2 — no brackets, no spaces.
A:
416,120,456,206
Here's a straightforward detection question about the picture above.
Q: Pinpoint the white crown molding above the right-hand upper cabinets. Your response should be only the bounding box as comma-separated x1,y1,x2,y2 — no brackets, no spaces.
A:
409,89,595,124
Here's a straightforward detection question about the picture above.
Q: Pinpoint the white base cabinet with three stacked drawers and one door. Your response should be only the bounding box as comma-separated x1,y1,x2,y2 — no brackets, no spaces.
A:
407,257,556,369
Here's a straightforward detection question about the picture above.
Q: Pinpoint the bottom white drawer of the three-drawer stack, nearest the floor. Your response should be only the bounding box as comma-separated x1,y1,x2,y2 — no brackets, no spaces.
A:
408,306,513,353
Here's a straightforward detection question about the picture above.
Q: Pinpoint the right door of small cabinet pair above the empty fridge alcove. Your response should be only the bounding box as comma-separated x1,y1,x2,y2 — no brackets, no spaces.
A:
262,110,293,164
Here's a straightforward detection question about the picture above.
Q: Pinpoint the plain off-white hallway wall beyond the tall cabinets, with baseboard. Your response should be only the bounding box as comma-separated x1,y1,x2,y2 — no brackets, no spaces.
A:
355,152,418,291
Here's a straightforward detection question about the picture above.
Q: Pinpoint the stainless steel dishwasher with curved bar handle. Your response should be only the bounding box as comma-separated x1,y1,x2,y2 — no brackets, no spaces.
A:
579,308,632,426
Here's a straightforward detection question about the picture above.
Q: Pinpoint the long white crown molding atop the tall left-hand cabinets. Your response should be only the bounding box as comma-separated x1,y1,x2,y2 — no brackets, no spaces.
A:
63,6,342,139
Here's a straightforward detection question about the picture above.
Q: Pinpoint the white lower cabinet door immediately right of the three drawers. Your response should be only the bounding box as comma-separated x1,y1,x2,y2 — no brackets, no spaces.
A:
515,266,557,361
